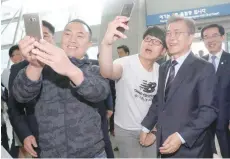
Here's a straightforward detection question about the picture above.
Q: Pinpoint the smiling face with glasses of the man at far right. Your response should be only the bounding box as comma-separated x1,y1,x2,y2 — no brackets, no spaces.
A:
203,27,224,54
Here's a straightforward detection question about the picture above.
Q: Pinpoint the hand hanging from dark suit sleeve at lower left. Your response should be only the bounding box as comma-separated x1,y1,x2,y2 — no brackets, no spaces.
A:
23,135,38,157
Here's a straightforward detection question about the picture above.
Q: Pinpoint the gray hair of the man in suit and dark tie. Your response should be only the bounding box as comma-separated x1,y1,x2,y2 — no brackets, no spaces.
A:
166,15,196,35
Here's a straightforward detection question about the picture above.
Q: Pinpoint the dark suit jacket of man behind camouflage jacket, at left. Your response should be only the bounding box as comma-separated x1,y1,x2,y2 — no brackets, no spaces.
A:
8,61,38,143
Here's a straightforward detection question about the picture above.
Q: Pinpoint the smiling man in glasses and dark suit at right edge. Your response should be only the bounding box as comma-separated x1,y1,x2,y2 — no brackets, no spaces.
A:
201,24,230,158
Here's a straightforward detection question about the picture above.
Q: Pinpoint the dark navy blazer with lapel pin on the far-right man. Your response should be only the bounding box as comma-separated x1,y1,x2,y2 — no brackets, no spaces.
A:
203,51,230,130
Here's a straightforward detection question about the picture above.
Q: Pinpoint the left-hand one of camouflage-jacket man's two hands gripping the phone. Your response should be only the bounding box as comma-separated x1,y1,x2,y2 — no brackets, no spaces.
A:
18,36,44,68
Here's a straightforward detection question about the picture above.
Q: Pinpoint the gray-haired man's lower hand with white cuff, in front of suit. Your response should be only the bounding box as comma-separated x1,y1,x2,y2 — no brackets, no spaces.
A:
160,133,182,154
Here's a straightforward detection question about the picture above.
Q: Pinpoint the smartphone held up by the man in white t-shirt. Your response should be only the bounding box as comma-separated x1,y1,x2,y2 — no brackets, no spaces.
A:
117,2,134,33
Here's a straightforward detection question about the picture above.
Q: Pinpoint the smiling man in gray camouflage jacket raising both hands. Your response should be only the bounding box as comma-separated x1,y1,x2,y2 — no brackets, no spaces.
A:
12,19,109,158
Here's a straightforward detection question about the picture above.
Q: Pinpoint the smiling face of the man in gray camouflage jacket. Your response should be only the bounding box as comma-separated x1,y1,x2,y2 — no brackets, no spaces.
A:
61,22,92,59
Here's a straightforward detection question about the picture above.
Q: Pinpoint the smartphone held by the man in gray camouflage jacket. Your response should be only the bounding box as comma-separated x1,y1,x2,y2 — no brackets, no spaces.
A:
23,13,43,41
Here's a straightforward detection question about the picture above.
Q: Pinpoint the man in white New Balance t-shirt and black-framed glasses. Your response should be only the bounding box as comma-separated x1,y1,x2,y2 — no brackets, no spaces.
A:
99,16,166,158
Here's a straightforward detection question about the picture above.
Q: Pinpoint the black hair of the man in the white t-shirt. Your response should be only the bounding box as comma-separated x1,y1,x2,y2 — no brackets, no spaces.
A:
143,26,166,48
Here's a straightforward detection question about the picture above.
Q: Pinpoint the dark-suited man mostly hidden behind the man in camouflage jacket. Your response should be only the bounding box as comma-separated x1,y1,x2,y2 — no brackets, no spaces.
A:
8,21,55,157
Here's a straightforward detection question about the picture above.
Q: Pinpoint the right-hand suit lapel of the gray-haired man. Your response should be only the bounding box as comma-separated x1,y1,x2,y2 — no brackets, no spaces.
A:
166,52,195,103
